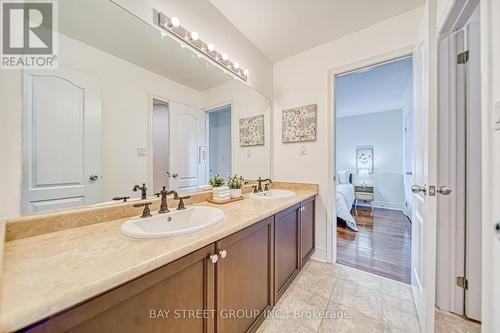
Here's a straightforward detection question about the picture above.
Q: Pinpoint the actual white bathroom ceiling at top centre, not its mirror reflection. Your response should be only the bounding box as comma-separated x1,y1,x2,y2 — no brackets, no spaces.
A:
210,0,425,62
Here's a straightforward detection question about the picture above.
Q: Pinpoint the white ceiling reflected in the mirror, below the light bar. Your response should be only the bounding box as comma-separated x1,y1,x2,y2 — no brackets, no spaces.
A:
58,0,232,91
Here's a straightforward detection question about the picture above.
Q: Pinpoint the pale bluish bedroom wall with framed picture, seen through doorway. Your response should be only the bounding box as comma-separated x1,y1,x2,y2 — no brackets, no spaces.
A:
336,110,404,210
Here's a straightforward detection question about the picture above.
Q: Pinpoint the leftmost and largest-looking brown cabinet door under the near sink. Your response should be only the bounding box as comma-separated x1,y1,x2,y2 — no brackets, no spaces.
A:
27,245,215,333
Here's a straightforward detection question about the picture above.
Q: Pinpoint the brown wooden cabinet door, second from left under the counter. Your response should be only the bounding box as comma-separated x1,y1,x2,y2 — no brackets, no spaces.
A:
216,216,274,333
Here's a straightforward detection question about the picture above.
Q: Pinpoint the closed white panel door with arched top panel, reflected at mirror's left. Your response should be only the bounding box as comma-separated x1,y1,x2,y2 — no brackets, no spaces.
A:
22,68,101,212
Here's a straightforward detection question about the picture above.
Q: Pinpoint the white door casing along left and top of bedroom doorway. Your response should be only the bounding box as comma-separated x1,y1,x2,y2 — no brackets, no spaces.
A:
326,44,413,263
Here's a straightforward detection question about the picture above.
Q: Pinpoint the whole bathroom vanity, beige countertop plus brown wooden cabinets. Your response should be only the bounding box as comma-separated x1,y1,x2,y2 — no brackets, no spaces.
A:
0,185,317,332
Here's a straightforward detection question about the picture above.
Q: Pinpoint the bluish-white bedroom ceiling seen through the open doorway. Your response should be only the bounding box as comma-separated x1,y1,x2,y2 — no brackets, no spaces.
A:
335,57,412,118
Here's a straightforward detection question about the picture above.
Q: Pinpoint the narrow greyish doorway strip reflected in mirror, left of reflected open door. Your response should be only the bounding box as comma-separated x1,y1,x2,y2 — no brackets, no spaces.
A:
152,100,170,193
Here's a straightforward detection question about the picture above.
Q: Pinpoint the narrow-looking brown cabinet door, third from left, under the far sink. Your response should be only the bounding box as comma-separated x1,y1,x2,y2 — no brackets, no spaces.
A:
274,205,300,301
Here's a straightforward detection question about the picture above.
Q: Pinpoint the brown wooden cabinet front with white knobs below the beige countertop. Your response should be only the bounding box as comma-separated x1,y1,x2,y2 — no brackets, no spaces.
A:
21,198,315,333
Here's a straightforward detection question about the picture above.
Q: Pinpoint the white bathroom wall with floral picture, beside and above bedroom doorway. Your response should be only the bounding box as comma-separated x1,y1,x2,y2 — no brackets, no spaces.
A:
273,9,422,259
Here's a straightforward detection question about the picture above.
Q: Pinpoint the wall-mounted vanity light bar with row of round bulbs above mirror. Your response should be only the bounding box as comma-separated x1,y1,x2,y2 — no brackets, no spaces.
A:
155,11,248,82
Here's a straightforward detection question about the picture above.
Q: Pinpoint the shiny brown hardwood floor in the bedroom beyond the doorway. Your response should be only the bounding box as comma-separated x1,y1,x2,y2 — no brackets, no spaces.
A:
337,207,411,283
